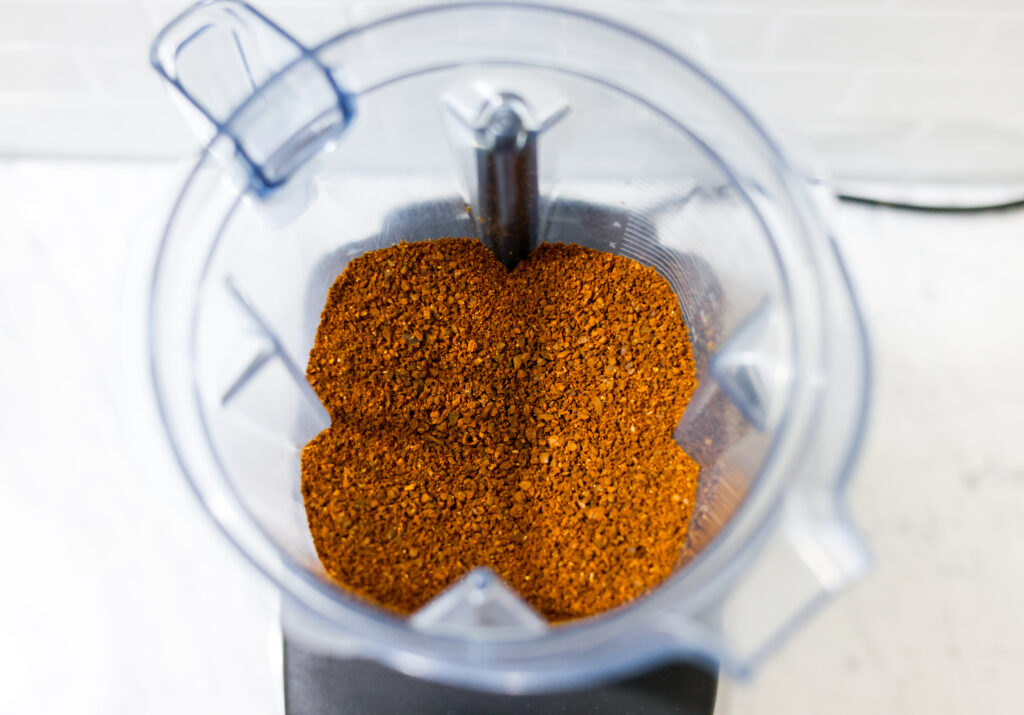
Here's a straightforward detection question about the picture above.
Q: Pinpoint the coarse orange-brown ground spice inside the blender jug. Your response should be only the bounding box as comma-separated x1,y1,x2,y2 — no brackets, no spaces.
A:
302,239,697,621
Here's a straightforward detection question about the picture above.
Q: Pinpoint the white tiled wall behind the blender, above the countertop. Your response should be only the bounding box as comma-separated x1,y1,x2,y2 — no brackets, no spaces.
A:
0,0,1024,179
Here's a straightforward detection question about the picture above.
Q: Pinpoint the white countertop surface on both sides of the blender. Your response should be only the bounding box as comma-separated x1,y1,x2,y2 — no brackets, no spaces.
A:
0,161,1024,715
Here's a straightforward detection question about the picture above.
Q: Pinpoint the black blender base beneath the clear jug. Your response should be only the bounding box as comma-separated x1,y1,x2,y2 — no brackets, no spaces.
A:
285,639,718,715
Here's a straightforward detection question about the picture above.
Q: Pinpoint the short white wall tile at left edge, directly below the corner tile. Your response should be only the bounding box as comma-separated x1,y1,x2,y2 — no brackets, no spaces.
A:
0,48,95,97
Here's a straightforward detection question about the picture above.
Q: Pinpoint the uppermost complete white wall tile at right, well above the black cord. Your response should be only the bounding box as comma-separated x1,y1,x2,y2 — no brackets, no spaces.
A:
772,13,978,69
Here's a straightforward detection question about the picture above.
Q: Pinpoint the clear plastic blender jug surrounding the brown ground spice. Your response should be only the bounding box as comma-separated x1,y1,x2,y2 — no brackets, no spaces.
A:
150,0,869,692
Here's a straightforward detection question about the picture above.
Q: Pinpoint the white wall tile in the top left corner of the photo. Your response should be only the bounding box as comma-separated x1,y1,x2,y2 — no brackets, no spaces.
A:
0,2,150,48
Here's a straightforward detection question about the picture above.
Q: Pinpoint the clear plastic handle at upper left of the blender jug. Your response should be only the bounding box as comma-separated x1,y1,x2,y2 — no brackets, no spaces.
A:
150,0,355,194
